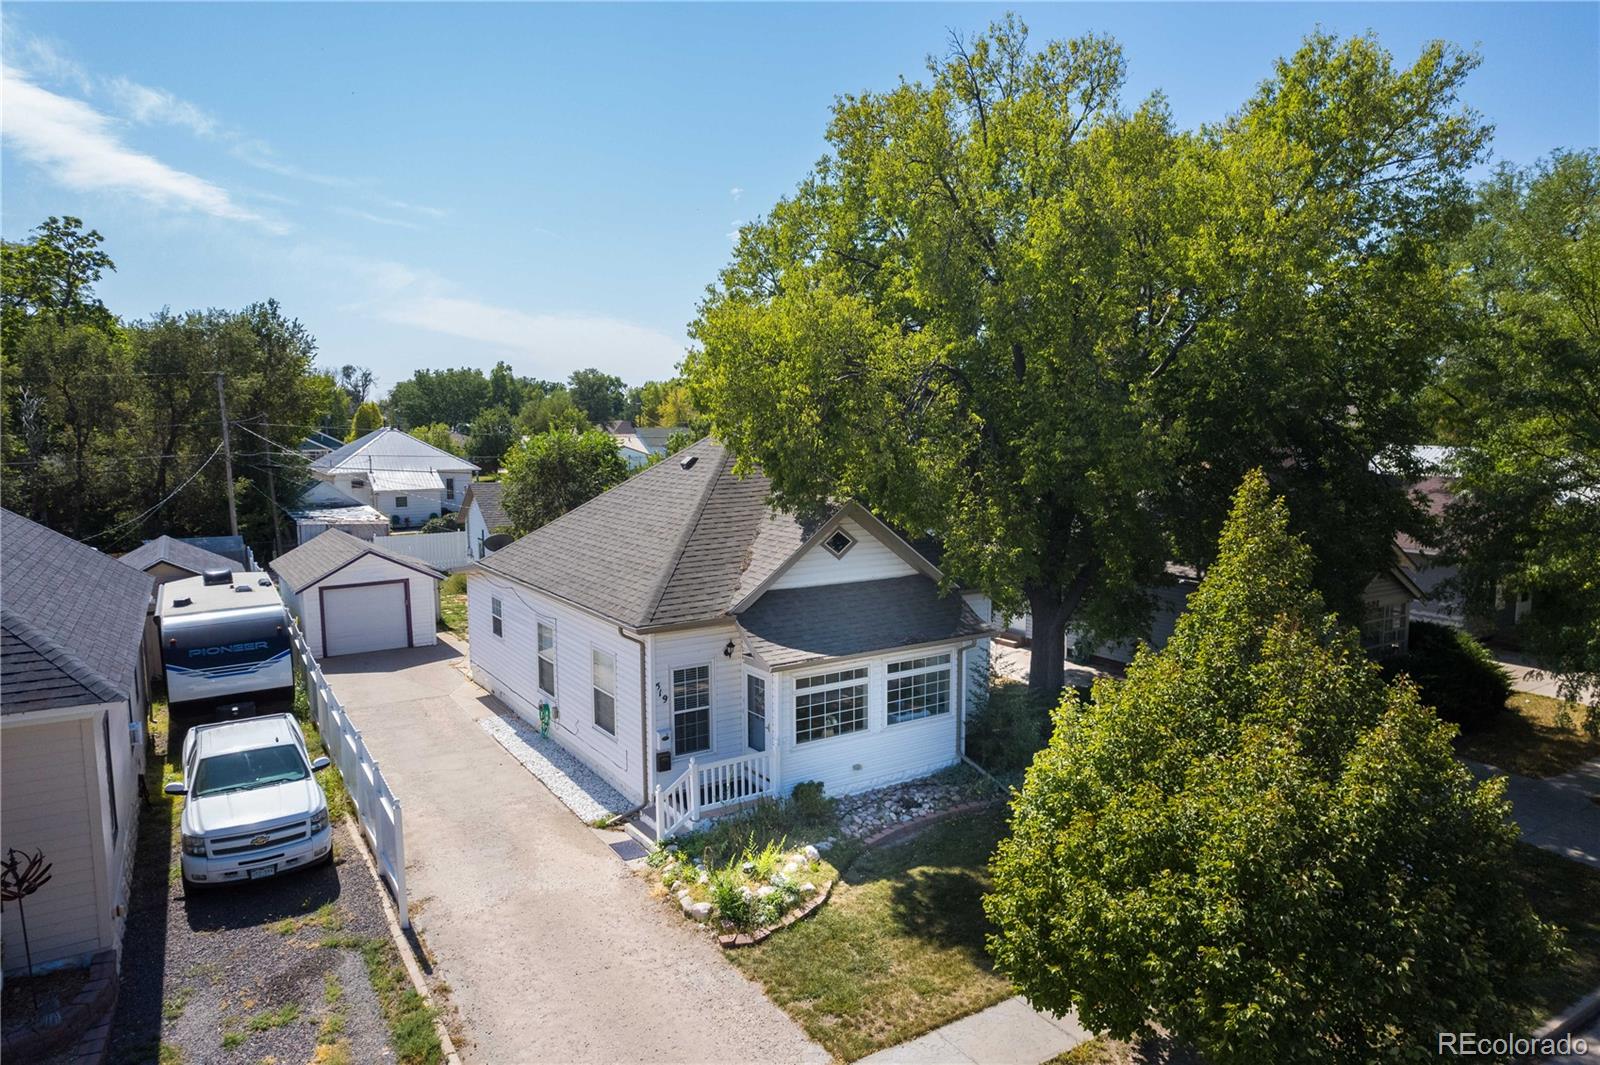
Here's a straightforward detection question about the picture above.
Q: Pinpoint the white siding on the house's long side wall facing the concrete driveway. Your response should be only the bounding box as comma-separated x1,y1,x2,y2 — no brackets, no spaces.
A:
467,569,653,803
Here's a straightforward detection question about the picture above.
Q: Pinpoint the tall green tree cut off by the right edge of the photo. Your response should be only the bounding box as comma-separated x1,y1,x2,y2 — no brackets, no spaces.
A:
1434,150,1600,731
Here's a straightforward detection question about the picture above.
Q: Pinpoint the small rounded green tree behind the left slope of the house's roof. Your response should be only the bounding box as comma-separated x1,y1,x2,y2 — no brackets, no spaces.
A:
501,429,627,536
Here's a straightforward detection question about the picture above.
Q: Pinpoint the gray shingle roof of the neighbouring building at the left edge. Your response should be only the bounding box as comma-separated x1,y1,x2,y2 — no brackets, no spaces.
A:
0,510,155,715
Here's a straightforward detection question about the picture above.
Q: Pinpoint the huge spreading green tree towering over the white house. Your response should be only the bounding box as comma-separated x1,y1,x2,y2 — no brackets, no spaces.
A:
685,19,1486,691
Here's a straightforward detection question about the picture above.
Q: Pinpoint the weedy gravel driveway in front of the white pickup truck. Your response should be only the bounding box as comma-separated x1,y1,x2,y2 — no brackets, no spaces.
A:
110,713,394,1065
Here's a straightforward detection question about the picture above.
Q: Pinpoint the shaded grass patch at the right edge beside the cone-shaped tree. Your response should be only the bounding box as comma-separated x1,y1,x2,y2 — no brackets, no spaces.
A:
1517,844,1600,1020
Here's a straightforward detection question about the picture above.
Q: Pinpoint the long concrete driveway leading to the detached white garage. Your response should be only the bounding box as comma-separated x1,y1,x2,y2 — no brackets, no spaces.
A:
323,643,827,1065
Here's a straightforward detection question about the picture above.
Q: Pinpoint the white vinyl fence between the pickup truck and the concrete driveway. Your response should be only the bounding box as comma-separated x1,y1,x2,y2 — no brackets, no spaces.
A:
290,617,411,929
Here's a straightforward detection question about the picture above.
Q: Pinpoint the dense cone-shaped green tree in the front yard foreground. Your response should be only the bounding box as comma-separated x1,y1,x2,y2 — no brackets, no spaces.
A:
984,472,1552,1065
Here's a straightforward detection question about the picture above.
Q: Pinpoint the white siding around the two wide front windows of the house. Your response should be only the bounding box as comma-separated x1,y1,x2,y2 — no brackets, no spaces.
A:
774,646,974,795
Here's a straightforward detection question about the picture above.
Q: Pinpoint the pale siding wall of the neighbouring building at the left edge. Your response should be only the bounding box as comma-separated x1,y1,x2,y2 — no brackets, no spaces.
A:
0,712,112,971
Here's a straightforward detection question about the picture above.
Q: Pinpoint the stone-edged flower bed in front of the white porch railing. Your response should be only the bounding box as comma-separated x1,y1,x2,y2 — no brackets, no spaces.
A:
650,840,838,947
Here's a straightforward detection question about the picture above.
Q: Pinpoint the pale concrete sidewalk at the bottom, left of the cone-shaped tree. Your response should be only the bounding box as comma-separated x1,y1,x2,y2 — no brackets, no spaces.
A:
856,996,1094,1065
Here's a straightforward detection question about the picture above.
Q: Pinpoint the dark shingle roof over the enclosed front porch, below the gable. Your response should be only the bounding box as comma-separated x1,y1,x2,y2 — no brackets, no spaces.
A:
738,574,990,668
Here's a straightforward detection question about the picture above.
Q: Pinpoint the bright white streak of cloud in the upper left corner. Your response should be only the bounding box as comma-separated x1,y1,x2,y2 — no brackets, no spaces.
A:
0,67,285,232
